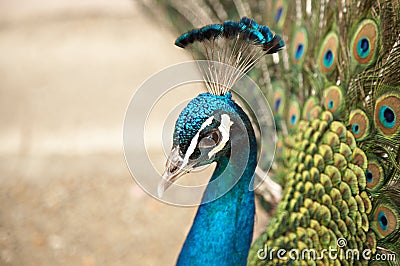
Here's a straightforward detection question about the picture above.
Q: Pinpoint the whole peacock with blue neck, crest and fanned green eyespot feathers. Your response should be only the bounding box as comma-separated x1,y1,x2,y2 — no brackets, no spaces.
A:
138,0,400,265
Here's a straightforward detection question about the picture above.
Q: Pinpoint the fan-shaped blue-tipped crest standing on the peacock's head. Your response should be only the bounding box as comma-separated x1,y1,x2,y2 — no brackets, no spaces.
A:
175,17,285,95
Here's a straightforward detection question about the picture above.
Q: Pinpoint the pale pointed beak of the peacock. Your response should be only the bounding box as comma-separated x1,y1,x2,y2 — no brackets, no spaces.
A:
158,147,197,198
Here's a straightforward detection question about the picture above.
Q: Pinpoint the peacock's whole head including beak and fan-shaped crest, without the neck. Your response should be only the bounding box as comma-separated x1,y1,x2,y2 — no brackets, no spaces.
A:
158,17,285,196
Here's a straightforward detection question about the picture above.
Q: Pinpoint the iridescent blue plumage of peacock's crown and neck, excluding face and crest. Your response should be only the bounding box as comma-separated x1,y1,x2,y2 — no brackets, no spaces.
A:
174,93,257,265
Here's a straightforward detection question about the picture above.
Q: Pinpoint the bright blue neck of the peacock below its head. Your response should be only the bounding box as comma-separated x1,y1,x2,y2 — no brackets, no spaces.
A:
177,119,257,265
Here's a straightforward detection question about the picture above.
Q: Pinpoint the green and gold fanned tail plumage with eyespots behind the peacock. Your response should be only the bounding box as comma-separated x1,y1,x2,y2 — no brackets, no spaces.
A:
143,0,400,265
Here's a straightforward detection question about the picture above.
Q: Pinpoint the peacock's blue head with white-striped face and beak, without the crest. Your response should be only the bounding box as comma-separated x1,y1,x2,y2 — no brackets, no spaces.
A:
158,92,254,196
